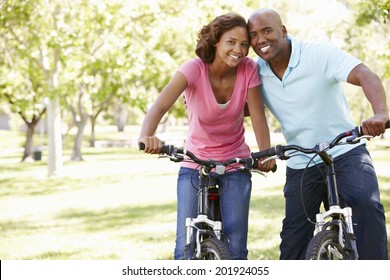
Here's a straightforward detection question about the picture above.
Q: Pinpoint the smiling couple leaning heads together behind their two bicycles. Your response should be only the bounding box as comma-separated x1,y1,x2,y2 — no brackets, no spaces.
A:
139,9,389,259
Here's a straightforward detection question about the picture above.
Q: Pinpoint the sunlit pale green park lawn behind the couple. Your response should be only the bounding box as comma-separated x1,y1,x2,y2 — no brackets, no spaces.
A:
0,127,390,260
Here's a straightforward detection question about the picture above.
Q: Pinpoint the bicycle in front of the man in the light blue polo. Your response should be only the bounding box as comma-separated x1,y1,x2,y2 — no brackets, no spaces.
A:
252,121,390,260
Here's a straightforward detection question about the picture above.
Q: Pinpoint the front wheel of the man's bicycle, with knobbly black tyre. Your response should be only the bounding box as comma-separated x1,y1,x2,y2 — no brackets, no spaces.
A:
306,230,350,260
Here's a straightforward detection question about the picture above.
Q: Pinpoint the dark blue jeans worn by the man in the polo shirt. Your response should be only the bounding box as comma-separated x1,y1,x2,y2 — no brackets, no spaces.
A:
280,145,388,260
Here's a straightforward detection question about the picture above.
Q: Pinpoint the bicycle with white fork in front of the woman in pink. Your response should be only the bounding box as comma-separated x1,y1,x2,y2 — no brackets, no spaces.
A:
139,143,275,260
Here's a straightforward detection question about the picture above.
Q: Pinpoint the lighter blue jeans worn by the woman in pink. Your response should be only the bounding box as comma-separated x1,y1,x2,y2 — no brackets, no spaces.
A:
174,167,252,260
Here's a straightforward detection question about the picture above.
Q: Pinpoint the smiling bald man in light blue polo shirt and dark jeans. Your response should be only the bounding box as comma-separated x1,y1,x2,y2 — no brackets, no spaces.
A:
248,9,389,259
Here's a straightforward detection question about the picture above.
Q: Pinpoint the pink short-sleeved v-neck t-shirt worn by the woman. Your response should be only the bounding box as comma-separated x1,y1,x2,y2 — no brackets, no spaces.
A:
178,57,261,168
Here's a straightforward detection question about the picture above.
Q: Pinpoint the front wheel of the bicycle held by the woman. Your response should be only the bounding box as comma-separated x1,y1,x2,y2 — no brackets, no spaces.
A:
200,237,231,260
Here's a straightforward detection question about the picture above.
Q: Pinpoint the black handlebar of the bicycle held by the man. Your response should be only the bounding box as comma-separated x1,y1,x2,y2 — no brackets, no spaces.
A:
251,121,390,160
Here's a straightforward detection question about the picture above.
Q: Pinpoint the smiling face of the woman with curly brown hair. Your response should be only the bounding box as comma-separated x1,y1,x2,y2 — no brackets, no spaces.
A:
215,26,249,68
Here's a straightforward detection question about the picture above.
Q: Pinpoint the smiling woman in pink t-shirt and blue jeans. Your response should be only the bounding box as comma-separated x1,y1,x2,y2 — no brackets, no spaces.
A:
139,13,274,259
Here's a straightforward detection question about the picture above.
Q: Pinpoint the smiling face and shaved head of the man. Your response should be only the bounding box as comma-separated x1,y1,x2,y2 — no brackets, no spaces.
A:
248,13,287,61
